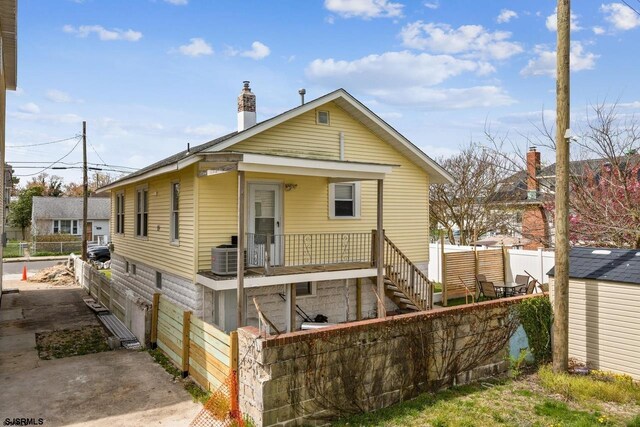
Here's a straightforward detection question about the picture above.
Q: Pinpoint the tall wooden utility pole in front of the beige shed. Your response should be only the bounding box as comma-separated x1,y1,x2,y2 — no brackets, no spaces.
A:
553,0,571,372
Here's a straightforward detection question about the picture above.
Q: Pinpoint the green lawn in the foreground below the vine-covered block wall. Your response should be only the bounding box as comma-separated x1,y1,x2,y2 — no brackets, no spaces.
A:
334,374,640,427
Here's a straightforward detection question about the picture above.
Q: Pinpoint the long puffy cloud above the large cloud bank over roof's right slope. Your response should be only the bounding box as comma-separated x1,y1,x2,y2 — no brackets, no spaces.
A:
400,21,522,59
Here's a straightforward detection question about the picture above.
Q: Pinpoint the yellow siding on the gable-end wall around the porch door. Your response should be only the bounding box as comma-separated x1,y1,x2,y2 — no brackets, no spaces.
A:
198,103,429,270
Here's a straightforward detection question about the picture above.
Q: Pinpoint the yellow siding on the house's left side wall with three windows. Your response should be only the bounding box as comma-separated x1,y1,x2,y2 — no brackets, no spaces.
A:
111,166,195,279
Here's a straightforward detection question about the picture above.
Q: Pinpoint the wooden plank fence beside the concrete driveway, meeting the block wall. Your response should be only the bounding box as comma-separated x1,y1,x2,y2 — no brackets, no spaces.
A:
151,294,238,396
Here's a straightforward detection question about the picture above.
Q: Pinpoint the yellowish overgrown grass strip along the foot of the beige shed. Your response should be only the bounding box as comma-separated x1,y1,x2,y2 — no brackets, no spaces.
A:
538,366,640,404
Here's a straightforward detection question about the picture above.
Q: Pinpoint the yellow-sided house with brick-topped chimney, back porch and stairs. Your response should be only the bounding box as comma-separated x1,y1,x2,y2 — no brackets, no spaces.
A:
101,82,451,332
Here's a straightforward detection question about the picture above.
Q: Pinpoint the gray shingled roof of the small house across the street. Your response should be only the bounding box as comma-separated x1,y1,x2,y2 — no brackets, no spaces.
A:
32,196,111,220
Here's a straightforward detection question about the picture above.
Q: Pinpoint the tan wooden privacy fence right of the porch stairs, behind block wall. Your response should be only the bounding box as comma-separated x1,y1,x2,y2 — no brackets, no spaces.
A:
442,247,505,306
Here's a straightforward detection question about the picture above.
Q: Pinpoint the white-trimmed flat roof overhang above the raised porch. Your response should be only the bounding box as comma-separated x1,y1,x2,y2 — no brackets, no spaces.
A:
200,153,397,181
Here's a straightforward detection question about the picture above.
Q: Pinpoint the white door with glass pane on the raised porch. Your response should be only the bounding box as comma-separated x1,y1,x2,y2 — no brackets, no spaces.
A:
247,183,284,266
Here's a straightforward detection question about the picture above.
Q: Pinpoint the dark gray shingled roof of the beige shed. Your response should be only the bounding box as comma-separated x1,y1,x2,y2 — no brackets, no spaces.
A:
547,248,640,285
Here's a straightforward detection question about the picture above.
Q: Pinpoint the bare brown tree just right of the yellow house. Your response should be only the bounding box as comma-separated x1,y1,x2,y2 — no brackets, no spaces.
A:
429,143,512,245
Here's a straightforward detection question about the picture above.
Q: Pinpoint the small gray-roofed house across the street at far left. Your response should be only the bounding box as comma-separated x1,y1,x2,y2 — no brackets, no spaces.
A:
31,196,111,244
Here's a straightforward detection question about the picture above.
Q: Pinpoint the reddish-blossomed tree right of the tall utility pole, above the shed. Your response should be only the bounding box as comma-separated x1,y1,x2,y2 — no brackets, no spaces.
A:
570,102,640,249
